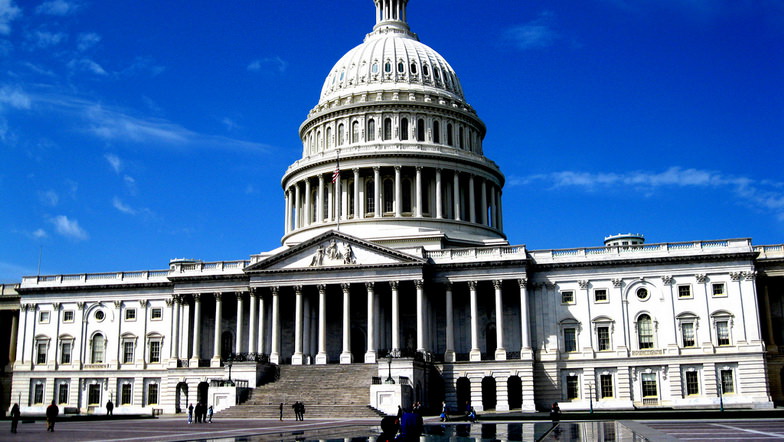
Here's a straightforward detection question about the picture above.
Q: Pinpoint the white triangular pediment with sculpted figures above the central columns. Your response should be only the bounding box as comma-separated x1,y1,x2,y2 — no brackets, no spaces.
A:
245,230,427,273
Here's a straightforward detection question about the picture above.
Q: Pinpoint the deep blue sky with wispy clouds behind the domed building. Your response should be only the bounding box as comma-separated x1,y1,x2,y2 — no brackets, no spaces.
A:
0,0,784,282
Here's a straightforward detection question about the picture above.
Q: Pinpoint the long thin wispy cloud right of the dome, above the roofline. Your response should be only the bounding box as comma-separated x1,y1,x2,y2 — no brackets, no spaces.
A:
508,167,784,221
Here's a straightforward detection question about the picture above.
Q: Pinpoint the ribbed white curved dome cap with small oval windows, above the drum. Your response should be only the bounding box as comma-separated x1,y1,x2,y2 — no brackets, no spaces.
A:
319,26,465,104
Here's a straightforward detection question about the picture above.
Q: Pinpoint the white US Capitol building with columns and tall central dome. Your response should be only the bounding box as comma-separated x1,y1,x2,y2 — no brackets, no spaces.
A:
0,0,784,414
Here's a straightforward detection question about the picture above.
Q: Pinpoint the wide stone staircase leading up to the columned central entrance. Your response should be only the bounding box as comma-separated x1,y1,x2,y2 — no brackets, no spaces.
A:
216,364,383,420
